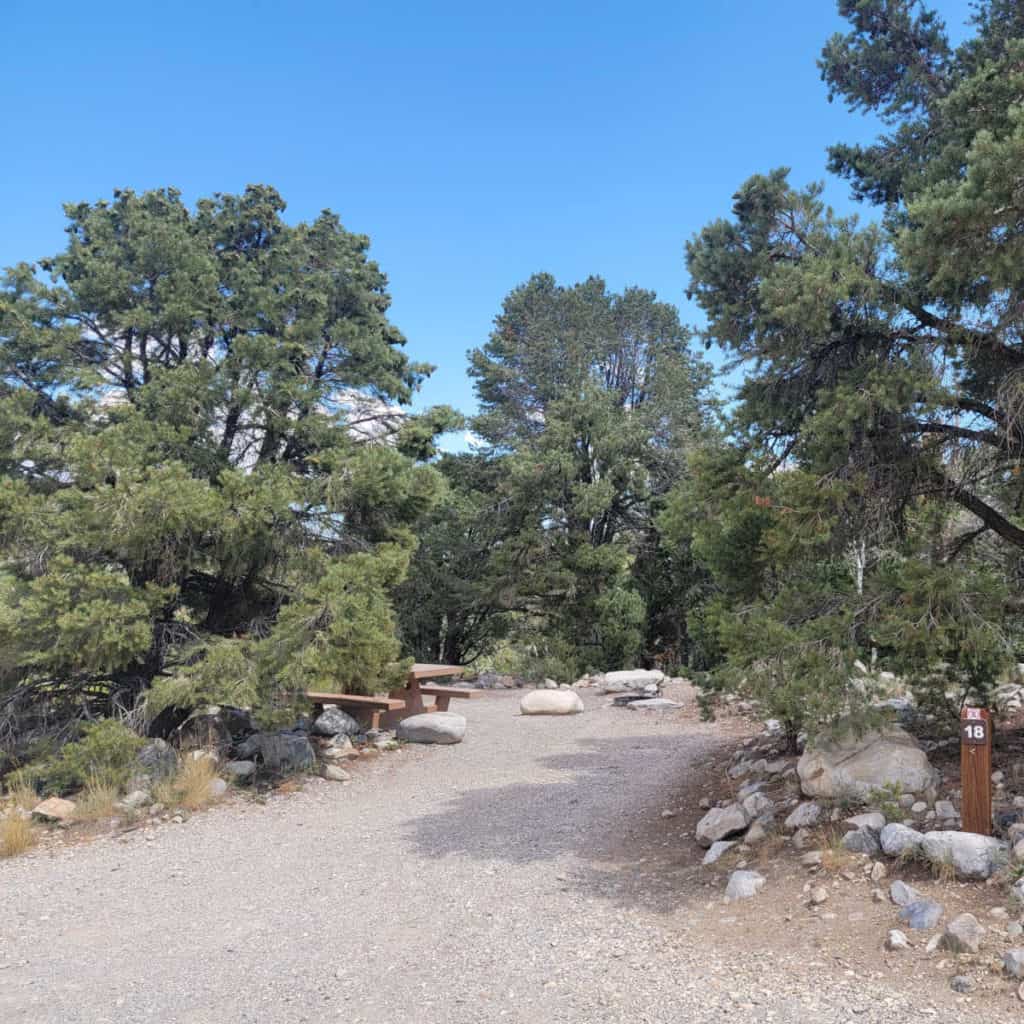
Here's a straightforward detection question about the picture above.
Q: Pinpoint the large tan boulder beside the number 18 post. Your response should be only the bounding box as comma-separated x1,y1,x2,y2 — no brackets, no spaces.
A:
797,726,937,799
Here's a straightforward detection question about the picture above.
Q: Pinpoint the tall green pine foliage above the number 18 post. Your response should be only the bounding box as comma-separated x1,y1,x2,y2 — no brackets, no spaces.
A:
675,0,1024,737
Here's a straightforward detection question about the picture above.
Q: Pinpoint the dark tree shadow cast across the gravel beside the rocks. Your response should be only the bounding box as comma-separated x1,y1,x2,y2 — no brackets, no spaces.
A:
407,733,729,912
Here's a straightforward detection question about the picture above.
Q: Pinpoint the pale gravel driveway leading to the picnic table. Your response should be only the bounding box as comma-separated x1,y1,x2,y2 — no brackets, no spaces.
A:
0,693,1013,1024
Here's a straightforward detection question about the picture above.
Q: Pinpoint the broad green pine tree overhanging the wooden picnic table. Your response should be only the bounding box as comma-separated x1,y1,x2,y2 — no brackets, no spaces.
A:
0,186,448,770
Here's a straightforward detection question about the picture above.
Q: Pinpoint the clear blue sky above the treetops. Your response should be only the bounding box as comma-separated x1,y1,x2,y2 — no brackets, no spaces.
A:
0,0,969,428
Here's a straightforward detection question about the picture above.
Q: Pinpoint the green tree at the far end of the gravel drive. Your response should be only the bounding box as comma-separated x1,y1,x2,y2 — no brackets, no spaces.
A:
470,274,709,678
